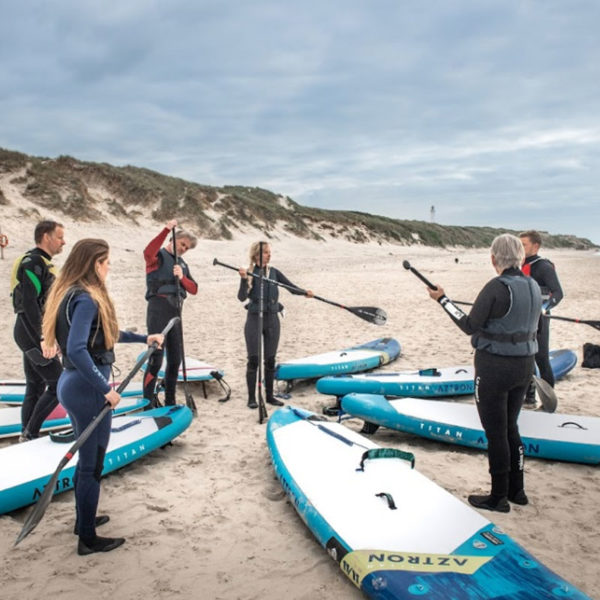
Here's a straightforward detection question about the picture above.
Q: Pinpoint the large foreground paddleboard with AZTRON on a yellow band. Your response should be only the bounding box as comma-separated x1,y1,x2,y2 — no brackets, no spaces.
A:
267,407,591,600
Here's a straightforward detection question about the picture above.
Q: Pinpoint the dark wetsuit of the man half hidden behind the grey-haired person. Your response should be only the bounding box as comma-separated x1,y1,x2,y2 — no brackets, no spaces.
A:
523,254,563,386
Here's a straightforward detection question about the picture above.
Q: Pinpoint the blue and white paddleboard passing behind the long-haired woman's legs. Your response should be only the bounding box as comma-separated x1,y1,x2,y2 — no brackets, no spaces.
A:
0,405,192,514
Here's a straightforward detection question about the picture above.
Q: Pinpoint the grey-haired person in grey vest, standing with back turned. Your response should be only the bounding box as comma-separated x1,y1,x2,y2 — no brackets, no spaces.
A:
427,233,542,512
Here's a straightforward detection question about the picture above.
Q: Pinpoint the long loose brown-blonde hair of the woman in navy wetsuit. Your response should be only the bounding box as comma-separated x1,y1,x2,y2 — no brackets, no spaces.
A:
42,238,119,350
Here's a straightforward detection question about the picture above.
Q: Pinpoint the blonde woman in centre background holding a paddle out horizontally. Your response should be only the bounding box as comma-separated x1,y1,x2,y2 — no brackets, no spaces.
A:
238,242,314,408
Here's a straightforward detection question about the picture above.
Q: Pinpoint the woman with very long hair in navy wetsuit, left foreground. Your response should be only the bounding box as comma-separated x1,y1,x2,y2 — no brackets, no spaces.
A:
42,238,163,555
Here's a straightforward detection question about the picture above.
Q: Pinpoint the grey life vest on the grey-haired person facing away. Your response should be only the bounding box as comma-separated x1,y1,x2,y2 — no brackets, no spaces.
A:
471,275,542,356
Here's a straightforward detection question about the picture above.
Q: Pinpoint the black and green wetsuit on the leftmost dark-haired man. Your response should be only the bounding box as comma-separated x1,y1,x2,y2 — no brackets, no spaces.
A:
11,248,62,439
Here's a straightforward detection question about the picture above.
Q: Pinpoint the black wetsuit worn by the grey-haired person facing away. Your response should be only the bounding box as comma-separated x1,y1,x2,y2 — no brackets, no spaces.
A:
439,268,542,497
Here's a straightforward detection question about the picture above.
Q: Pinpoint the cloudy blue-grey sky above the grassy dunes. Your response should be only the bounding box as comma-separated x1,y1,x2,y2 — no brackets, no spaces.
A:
0,0,600,244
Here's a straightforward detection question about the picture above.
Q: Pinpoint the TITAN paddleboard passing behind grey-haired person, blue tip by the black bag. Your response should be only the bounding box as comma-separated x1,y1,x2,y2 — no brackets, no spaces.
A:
317,349,577,398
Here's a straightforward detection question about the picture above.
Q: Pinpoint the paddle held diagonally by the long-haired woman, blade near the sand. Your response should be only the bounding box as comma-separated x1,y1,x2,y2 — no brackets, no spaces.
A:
14,317,179,546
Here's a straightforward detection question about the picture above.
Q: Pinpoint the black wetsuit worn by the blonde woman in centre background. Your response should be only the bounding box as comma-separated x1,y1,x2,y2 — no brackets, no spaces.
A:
238,266,306,402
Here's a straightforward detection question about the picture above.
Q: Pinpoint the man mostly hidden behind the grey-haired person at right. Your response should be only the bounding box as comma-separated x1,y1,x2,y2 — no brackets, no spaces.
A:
519,230,563,408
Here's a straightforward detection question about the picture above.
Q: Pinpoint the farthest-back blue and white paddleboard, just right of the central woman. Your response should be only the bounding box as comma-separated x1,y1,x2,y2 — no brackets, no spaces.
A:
275,338,400,380
